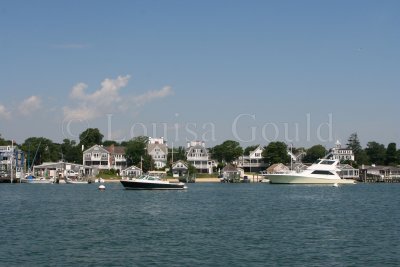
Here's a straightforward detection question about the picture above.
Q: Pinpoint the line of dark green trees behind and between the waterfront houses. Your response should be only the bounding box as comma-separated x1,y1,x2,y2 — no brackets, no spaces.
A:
0,131,400,173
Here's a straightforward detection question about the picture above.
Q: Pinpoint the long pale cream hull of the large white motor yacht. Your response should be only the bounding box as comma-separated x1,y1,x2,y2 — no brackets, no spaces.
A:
267,174,355,184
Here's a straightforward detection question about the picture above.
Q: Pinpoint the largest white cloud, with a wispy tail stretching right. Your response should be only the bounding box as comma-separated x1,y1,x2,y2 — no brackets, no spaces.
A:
64,75,172,120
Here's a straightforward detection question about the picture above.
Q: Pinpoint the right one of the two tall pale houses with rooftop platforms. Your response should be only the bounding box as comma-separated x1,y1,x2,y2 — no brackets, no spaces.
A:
186,141,213,174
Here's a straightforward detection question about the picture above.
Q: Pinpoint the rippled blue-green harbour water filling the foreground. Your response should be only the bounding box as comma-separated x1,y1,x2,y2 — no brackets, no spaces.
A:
0,183,400,266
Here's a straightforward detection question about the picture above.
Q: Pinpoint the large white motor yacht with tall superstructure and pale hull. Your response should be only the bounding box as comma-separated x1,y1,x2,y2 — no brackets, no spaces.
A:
266,159,355,184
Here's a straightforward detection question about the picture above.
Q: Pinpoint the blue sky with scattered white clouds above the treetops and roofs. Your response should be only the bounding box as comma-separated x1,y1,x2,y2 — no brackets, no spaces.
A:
0,0,400,147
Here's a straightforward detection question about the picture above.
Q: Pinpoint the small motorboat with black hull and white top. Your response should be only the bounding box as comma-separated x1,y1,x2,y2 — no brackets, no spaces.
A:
121,175,187,190
